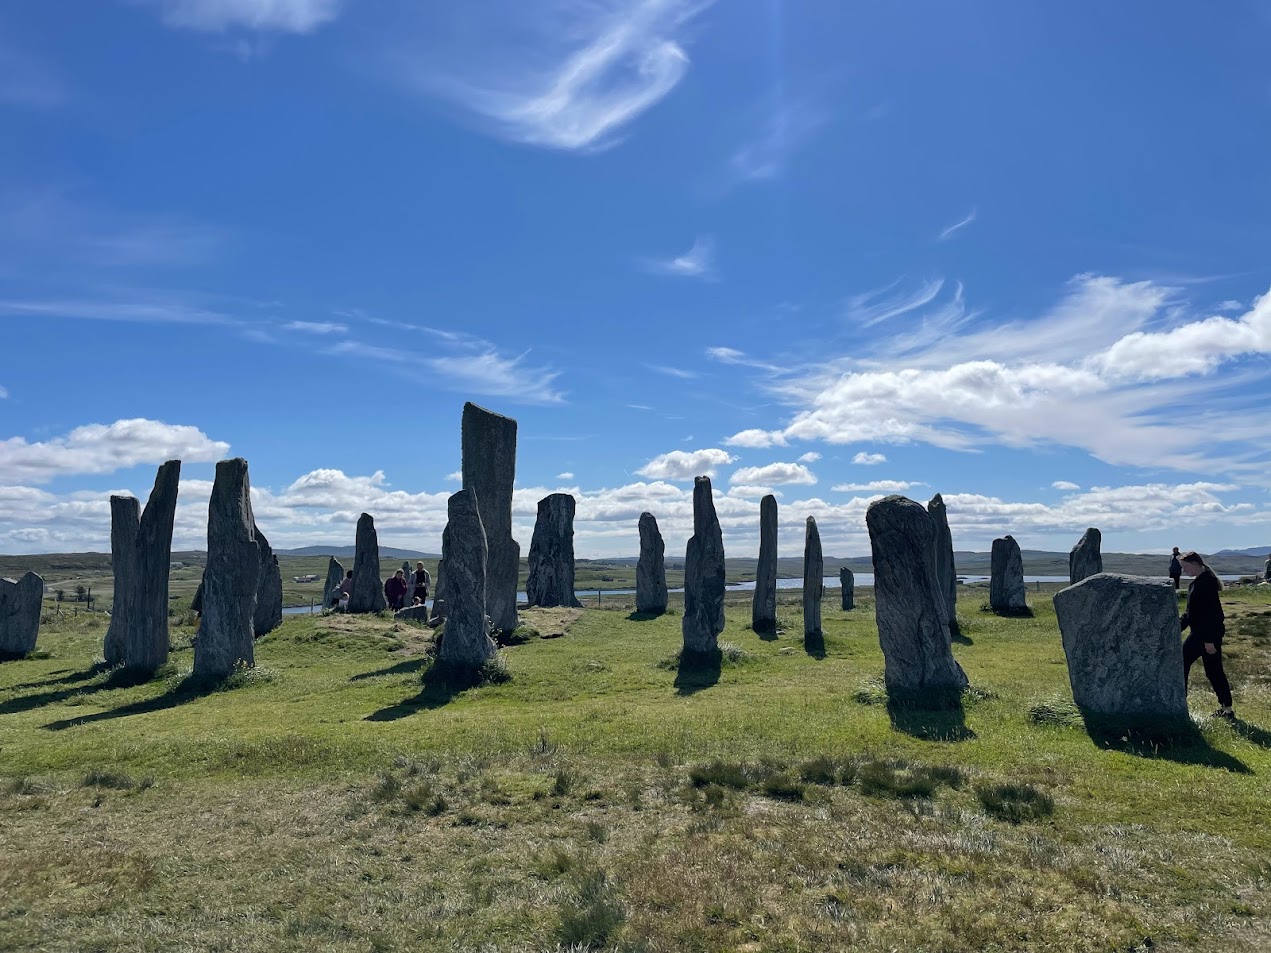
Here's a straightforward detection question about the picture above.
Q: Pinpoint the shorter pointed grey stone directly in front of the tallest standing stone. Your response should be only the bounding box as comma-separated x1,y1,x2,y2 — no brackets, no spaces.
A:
437,487,496,668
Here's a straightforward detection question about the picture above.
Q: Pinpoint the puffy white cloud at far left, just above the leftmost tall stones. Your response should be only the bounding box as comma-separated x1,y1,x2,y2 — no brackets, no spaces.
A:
0,418,230,483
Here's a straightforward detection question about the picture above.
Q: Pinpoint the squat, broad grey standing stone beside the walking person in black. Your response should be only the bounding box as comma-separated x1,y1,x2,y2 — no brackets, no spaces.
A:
1055,573,1187,718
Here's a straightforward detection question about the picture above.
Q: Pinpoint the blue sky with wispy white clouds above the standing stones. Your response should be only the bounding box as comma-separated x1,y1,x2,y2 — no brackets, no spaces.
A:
0,0,1271,555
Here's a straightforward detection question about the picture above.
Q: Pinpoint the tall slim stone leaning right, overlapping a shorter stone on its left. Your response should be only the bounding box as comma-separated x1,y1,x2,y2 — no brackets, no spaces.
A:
126,460,183,673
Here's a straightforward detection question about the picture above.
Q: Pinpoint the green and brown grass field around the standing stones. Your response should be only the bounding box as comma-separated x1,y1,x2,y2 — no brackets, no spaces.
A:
0,588,1271,952
